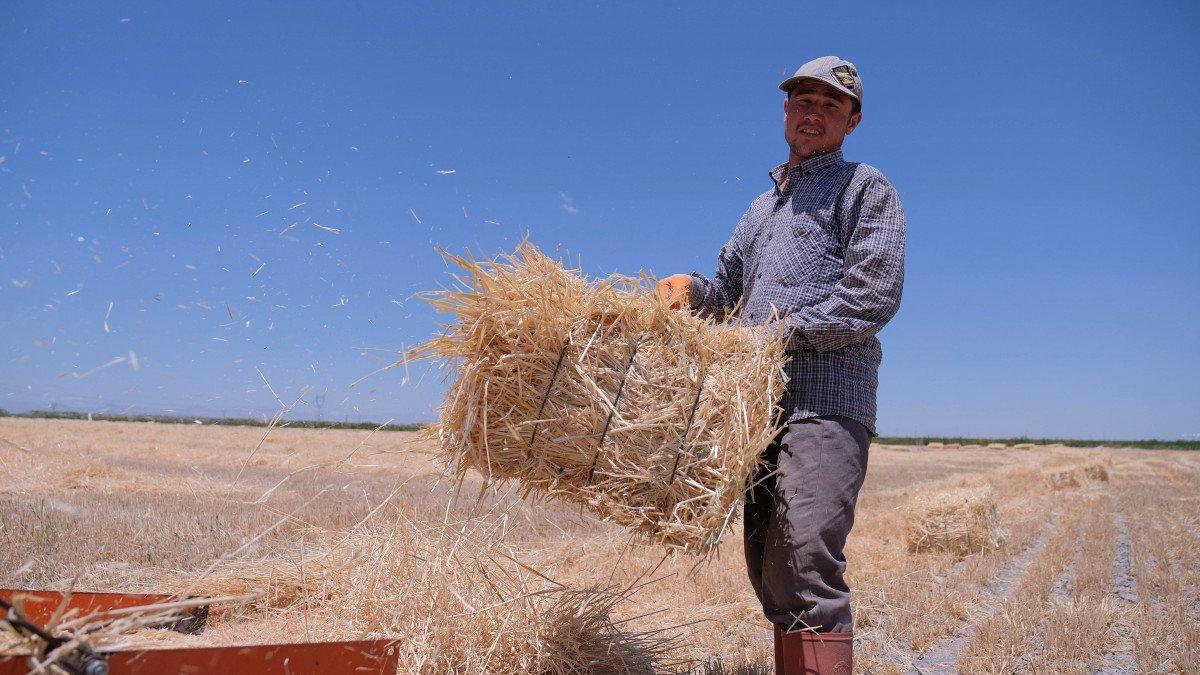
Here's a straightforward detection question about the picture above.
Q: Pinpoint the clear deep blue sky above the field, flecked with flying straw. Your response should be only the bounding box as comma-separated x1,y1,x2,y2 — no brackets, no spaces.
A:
0,2,1200,438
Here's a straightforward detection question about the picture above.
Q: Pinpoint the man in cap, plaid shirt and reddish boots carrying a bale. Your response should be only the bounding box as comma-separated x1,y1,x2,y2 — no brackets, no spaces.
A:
658,56,905,674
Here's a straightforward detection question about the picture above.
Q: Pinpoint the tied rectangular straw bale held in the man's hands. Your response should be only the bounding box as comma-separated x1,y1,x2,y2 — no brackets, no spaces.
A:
410,244,785,552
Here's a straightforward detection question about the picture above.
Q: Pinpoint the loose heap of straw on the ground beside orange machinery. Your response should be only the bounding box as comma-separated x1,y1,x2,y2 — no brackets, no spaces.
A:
0,509,684,675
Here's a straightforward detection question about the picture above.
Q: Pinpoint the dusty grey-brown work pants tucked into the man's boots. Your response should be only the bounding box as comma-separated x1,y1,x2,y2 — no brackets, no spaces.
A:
744,416,871,633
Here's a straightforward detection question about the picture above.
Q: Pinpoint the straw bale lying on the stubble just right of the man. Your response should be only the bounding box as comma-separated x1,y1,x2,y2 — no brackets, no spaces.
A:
905,486,1004,556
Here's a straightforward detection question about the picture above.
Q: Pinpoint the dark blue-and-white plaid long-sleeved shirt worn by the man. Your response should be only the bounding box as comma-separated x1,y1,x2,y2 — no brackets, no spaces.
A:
691,150,905,434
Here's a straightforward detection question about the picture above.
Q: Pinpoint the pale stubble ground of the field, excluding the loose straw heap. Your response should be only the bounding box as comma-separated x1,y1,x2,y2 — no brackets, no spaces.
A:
0,418,1200,673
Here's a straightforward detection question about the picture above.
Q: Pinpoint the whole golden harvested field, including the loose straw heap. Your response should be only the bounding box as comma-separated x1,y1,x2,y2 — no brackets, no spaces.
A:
0,419,1200,673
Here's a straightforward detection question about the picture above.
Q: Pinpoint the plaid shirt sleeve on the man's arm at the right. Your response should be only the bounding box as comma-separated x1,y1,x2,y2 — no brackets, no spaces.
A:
784,172,905,352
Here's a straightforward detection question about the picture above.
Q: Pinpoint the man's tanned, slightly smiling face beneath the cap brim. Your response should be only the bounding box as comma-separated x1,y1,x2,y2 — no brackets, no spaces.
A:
784,79,863,162
